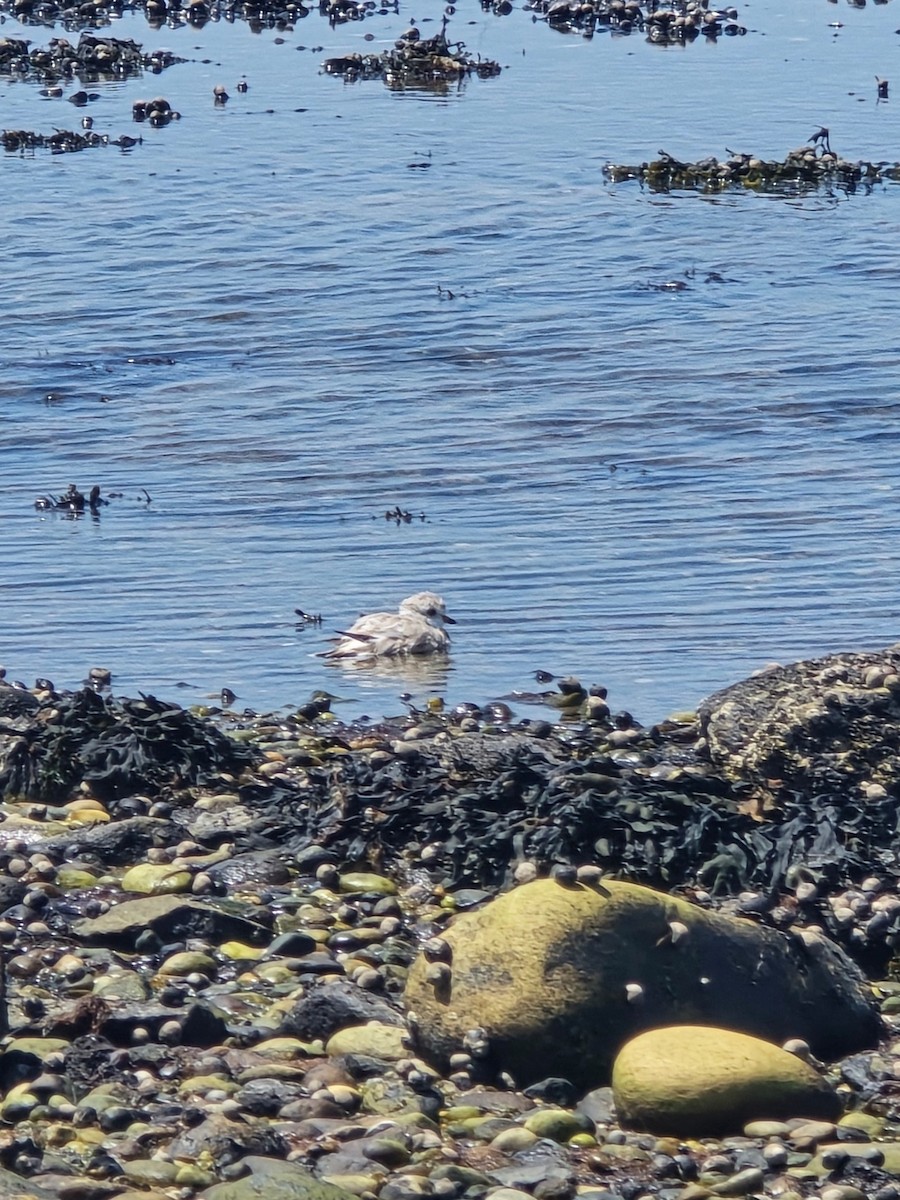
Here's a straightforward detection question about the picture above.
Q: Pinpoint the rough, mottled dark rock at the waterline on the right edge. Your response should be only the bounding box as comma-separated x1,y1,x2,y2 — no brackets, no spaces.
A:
700,646,900,800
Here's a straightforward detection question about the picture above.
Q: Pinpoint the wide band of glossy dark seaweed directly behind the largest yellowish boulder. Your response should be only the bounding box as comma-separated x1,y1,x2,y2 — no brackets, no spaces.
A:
270,720,900,895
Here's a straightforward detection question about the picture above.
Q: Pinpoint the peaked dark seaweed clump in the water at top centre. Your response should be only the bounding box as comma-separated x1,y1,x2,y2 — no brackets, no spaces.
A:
323,29,500,89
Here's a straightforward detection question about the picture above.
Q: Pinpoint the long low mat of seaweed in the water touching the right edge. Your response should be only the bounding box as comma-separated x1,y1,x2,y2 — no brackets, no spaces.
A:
604,146,900,194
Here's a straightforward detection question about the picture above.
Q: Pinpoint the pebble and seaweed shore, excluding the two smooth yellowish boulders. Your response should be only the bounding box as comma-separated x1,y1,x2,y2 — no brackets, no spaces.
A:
0,648,900,1200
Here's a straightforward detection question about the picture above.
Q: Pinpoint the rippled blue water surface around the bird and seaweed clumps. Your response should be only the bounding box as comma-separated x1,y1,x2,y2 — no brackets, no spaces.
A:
0,0,900,720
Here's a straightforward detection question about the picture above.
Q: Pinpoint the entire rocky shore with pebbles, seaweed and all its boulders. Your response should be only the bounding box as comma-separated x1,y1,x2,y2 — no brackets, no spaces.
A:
0,647,900,1200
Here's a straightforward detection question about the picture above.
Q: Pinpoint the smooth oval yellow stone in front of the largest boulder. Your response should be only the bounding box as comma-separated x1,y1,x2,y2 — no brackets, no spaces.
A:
612,1025,841,1138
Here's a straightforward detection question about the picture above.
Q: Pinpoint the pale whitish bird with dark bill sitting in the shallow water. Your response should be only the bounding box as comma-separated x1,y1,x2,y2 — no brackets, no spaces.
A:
320,592,456,662
